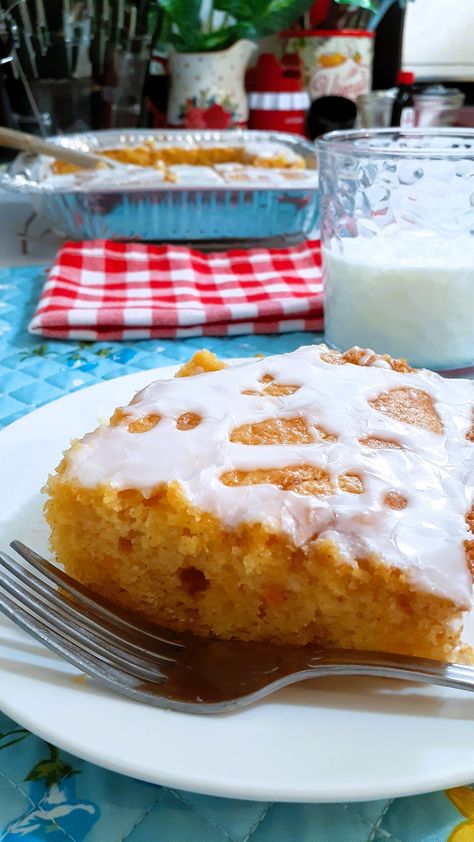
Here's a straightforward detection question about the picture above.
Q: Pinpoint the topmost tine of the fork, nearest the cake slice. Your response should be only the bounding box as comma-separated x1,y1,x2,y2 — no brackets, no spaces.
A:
10,541,183,647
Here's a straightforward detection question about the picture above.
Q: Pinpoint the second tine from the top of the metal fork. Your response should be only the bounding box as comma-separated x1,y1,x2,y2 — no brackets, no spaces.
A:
0,552,173,661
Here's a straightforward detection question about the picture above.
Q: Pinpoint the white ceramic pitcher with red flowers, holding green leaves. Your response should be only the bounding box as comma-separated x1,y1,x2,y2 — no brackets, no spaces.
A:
167,40,255,129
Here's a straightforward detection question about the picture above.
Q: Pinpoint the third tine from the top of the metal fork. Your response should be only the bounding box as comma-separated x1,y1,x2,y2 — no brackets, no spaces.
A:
0,556,173,682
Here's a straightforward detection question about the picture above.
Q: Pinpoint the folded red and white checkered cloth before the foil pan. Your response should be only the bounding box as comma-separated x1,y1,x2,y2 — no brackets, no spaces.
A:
29,240,323,340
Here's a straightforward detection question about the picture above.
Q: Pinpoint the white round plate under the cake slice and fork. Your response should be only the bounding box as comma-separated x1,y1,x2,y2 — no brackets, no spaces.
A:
0,367,474,801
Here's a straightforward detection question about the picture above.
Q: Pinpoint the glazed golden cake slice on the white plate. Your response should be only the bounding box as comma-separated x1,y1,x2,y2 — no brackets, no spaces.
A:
46,345,474,660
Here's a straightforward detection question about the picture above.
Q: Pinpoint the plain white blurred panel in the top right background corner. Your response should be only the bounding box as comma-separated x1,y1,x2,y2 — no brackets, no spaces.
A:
403,0,474,81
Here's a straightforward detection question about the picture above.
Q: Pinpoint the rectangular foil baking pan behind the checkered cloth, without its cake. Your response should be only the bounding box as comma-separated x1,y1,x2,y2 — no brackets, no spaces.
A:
0,130,319,241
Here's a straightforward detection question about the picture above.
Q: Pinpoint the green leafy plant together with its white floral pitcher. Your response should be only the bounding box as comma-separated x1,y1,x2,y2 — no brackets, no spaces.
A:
160,0,318,129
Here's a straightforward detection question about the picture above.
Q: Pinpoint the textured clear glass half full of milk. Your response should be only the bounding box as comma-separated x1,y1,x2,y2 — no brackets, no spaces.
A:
319,129,474,370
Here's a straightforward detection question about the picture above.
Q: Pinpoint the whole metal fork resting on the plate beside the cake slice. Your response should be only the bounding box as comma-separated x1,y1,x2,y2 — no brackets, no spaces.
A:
0,541,474,713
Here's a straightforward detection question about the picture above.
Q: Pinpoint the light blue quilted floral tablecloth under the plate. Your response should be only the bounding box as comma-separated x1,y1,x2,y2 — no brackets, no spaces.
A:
0,266,474,842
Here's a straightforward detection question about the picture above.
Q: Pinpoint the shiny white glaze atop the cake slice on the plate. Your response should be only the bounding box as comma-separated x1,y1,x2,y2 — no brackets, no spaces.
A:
67,346,474,608
